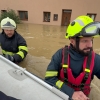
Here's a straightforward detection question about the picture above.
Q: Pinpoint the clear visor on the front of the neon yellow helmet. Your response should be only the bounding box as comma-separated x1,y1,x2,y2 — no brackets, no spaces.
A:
80,22,100,37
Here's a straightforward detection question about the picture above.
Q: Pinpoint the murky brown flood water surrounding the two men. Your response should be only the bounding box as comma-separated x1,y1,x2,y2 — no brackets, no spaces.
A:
0,24,100,100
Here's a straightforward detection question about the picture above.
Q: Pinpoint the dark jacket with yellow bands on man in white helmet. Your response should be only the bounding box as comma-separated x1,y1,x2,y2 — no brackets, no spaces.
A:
0,31,28,63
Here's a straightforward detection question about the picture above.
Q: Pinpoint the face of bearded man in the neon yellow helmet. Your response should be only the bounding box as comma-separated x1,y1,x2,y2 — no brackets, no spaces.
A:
71,37,93,55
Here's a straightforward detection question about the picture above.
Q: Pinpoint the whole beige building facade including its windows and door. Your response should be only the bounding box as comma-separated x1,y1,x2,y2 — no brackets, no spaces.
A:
0,0,100,26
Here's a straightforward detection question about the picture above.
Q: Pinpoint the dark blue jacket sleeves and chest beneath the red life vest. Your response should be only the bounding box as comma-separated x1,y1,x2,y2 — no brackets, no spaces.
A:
45,47,100,97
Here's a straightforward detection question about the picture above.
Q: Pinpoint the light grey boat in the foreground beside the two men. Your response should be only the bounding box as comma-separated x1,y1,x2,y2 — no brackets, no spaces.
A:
0,55,69,100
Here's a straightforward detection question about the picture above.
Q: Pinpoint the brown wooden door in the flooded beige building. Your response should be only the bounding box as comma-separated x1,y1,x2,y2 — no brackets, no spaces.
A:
61,10,72,26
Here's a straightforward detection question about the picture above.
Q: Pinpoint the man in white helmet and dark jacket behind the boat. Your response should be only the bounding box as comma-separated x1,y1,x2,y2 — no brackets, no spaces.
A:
0,17,28,63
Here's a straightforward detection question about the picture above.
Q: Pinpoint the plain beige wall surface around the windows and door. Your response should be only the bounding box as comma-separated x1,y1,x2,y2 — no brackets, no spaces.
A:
0,0,100,25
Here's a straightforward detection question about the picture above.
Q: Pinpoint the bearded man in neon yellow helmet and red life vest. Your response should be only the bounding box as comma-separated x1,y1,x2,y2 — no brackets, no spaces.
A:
45,15,100,100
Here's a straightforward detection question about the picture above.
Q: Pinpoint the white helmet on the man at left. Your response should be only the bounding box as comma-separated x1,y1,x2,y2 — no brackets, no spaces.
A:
1,17,16,30
